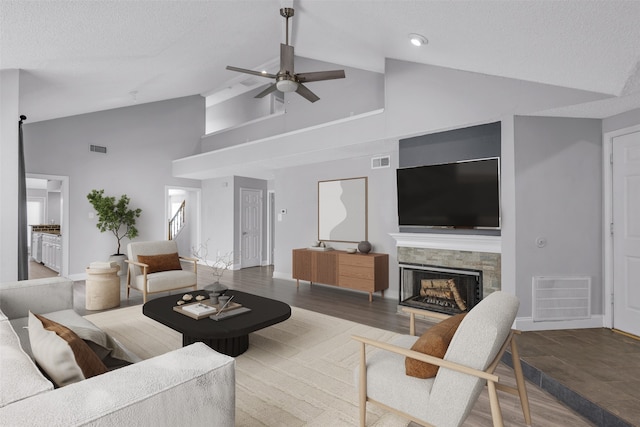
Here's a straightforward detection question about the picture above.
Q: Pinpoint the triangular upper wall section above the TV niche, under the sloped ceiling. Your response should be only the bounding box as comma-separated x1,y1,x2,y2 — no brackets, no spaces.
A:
385,59,607,137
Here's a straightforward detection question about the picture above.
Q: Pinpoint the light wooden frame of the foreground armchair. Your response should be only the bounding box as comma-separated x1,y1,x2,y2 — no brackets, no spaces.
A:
352,307,531,427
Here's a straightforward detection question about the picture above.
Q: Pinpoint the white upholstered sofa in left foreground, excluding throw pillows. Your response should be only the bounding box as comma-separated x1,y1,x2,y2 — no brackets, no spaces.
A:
0,278,235,427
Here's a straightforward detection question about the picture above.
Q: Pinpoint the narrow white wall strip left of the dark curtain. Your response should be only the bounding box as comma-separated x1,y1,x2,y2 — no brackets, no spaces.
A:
0,70,20,282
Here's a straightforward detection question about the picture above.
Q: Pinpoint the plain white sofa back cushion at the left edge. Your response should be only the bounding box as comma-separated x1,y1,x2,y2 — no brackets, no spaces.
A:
0,320,53,408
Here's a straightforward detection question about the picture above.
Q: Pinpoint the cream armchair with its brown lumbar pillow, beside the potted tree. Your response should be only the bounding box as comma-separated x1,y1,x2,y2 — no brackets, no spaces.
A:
126,240,198,302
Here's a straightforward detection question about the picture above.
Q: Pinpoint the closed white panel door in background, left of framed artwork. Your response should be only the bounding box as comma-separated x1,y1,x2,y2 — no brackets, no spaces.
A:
240,188,262,268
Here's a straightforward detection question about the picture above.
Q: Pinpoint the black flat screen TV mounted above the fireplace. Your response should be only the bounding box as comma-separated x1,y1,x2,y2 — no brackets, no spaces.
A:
397,158,500,229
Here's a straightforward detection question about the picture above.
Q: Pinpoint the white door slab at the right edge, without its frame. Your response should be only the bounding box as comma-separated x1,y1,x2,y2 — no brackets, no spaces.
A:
612,132,640,336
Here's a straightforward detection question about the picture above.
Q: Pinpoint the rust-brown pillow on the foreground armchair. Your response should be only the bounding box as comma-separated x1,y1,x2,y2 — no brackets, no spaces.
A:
405,313,466,378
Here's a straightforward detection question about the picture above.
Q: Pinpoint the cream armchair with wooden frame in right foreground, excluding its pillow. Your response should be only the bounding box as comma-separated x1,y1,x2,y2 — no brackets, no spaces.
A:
354,292,531,427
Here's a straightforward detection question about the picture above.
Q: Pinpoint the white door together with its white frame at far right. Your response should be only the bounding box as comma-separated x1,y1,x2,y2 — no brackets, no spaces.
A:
605,126,640,337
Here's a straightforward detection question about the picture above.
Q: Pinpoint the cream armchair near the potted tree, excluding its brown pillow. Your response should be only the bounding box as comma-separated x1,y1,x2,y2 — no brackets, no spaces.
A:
125,240,198,302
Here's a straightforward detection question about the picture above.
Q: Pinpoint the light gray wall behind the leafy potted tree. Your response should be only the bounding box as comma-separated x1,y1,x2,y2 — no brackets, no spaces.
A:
24,96,204,276
